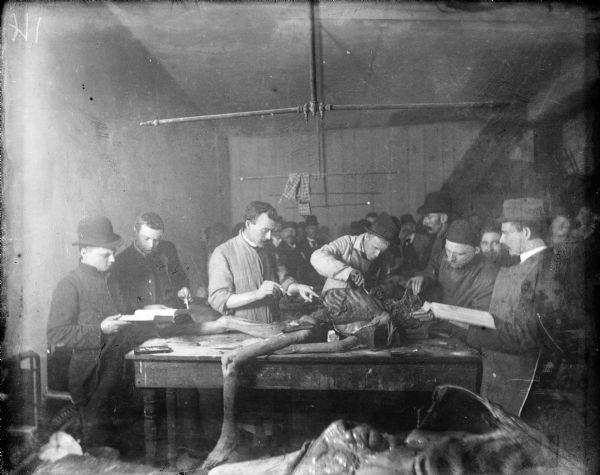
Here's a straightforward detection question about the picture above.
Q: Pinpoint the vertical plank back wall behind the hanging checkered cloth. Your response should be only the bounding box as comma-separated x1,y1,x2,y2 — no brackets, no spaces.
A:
229,121,483,238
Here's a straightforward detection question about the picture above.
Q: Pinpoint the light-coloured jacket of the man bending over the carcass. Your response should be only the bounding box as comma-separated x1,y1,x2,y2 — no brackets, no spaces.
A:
310,233,371,294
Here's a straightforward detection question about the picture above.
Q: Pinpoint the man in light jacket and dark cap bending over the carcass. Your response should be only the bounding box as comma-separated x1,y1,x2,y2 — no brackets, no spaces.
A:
310,212,400,294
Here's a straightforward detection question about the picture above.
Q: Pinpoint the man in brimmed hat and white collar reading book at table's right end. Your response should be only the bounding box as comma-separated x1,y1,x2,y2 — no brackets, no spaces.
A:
440,198,570,415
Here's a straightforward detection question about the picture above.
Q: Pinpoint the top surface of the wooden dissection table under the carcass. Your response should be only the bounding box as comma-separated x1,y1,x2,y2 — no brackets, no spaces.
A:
127,332,480,364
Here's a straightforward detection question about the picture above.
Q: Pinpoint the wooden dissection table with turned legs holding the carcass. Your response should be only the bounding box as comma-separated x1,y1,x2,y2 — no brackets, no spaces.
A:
127,333,481,464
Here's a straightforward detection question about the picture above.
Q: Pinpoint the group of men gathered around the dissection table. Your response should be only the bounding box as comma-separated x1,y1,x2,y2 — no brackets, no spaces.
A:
48,192,584,450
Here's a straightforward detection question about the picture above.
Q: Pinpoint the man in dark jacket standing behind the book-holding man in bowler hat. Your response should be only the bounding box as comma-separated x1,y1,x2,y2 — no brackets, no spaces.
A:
111,212,191,313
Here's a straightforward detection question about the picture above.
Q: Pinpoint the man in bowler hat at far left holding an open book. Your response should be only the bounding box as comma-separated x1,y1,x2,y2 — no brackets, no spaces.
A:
47,216,143,446
